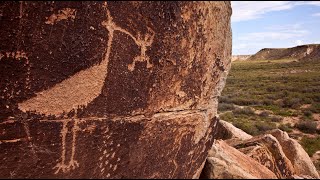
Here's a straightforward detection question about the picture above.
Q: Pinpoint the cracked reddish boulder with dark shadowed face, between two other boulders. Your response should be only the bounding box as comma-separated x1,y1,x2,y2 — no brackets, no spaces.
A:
231,134,294,179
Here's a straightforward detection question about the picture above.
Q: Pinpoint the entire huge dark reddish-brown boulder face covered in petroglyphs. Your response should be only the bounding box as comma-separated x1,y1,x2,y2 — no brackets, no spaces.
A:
0,1,231,178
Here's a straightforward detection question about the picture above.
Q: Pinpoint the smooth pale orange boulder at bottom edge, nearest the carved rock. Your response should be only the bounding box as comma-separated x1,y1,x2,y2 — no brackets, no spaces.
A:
200,140,277,179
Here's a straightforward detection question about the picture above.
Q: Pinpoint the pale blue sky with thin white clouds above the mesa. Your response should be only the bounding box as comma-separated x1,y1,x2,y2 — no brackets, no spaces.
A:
231,1,320,55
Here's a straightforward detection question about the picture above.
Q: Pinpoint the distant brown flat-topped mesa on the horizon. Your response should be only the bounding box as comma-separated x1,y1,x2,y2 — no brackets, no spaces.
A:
247,44,320,61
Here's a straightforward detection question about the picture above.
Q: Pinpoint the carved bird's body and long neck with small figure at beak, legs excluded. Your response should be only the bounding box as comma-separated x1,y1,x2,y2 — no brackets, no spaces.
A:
18,4,154,116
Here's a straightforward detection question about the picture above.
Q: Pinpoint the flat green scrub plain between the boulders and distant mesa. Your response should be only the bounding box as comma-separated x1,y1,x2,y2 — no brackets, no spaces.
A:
218,59,320,141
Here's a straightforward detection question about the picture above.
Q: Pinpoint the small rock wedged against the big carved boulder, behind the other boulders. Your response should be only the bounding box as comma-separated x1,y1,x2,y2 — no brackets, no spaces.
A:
215,119,252,140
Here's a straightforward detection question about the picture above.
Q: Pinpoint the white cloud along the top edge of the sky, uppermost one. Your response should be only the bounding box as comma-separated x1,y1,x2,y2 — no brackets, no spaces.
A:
231,1,320,22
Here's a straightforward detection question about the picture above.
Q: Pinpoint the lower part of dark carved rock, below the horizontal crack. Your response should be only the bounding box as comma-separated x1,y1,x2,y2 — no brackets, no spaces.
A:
0,112,216,178
